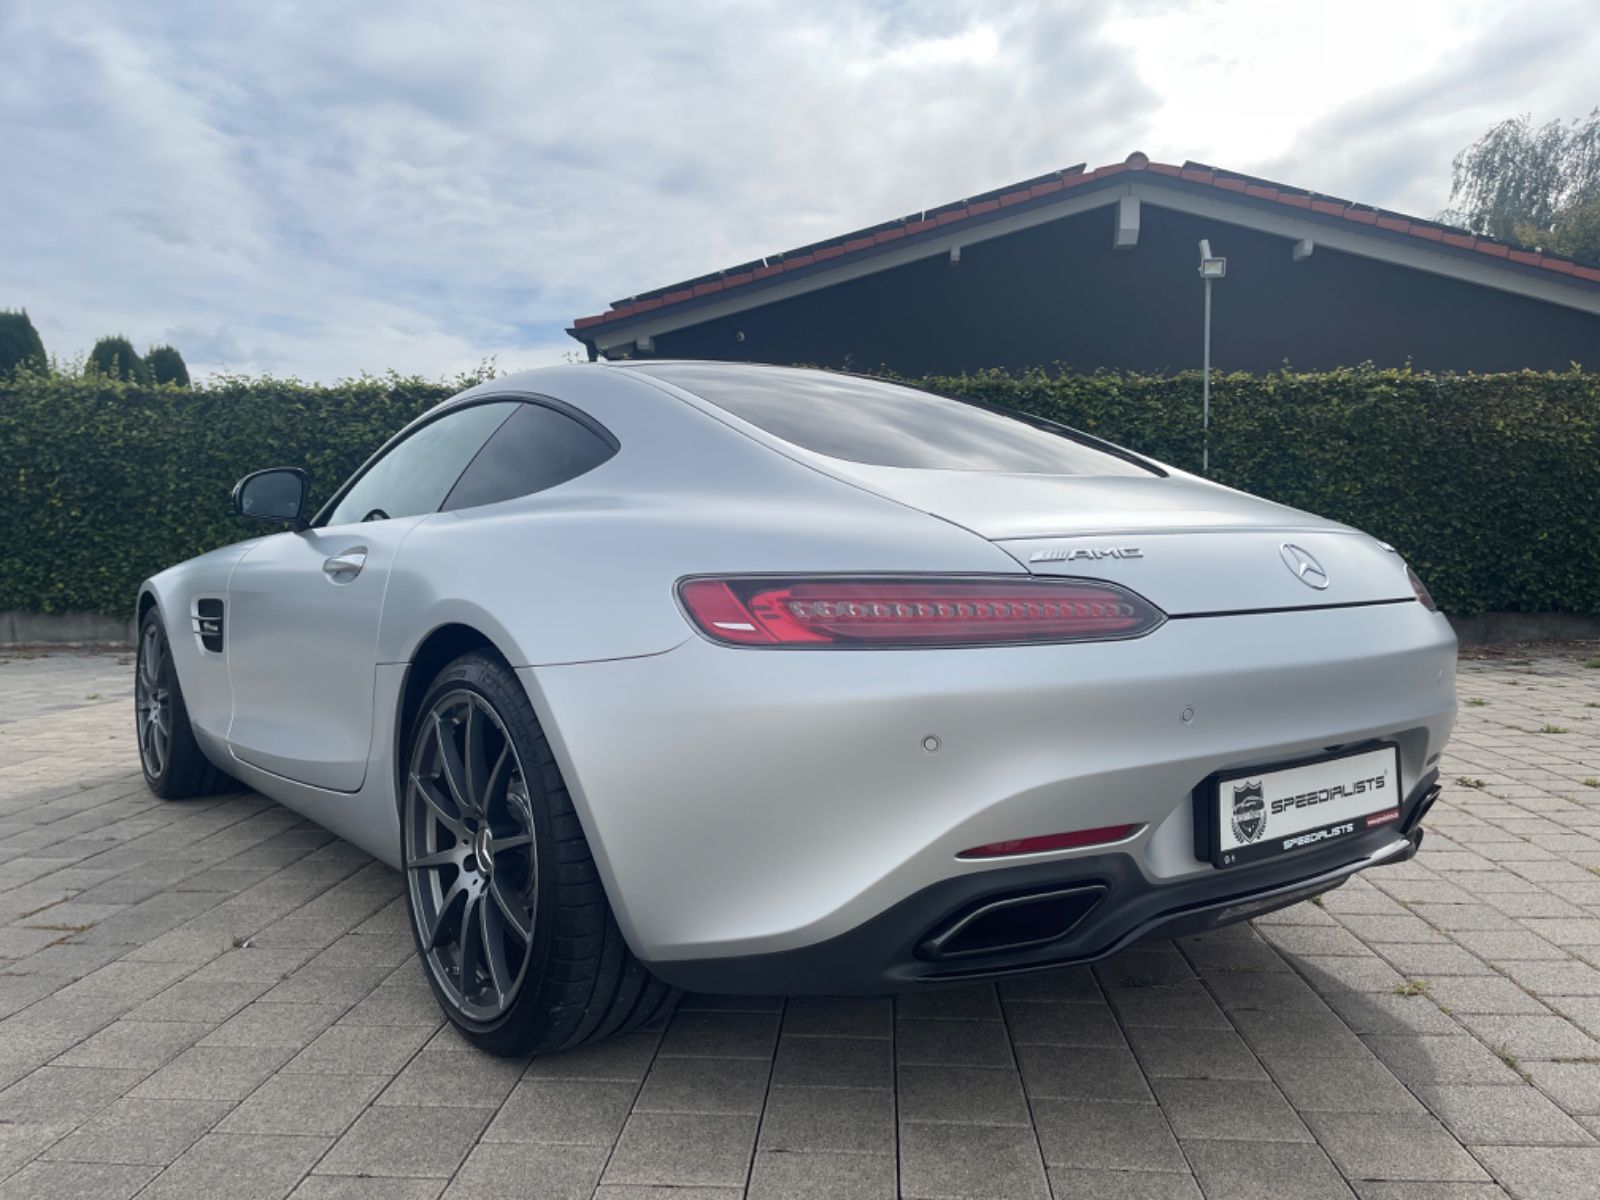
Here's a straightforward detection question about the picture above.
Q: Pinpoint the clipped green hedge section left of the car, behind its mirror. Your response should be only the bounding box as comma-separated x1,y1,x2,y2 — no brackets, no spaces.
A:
0,373,456,616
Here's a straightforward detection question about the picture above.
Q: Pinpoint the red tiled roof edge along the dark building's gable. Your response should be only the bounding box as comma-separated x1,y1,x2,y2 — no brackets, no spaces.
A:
571,152,1600,334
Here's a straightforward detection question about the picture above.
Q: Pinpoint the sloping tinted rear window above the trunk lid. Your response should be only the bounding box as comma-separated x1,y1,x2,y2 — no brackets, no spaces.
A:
635,363,1157,477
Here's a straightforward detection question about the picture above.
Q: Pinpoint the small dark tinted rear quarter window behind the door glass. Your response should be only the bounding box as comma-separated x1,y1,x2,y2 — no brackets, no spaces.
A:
445,403,616,509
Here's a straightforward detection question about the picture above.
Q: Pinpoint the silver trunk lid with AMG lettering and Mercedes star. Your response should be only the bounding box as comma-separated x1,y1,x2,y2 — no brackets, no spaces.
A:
812,459,1414,616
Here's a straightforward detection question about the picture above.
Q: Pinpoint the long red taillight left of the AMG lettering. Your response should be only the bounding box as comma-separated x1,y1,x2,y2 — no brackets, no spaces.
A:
678,578,1166,646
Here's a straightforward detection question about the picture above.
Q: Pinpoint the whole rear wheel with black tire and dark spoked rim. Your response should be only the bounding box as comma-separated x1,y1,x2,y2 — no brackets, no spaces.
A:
400,651,677,1056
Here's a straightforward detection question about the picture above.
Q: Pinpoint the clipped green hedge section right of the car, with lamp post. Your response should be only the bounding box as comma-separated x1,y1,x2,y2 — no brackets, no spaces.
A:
928,368,1600,616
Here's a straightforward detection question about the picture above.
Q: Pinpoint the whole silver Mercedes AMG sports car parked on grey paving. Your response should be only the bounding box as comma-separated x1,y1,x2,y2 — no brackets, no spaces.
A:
136,362,1456,1053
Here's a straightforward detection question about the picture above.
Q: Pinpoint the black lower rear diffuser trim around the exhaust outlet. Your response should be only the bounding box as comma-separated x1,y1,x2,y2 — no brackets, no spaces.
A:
651,774,1438,995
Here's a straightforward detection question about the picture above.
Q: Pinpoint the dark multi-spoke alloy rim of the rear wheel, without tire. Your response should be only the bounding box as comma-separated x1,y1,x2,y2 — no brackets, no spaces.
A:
405,690,539,1021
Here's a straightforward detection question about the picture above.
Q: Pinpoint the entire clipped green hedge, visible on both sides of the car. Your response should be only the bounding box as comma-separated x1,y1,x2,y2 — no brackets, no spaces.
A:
0,370,1600,616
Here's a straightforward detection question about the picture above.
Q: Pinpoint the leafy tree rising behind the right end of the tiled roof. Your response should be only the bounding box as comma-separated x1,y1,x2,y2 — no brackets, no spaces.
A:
1442,109,1600,265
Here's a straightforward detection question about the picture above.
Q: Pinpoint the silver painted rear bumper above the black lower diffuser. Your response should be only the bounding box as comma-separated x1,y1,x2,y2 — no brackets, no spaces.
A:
518,603,1456,966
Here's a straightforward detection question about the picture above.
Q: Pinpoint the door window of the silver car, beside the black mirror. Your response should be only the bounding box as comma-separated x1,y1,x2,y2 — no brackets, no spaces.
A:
323,400,520,525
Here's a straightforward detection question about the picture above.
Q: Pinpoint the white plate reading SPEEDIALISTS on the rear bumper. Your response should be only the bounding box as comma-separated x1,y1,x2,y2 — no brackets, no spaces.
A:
1203,744,1402,867
